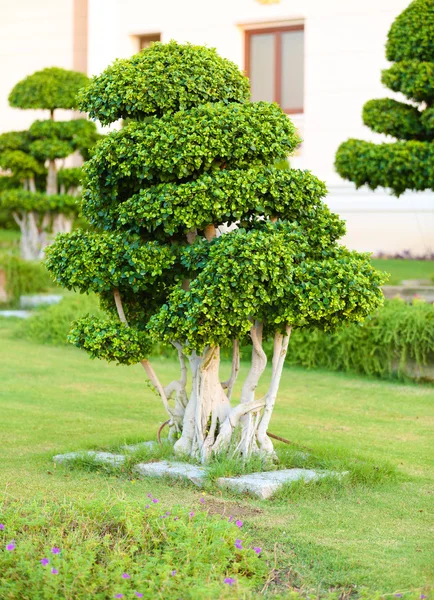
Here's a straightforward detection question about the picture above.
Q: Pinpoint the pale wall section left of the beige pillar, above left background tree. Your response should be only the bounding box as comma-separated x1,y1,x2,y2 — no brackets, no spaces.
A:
0,0,73,132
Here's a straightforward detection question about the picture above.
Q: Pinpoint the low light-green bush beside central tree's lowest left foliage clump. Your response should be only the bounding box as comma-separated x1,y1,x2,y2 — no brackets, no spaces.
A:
17,294,104,346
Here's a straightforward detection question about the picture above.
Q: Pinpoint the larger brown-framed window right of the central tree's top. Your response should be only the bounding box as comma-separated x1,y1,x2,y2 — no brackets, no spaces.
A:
245,25,304,114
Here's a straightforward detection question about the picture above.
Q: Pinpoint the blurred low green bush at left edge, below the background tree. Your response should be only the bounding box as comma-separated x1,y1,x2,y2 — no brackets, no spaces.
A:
0,254,53,305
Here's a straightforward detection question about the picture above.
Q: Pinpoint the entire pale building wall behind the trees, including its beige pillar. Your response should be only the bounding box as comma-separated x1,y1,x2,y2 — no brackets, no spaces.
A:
0,0,434,254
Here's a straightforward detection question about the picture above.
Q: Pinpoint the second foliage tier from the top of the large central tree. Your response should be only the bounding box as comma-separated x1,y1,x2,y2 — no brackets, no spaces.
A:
84,102,300,203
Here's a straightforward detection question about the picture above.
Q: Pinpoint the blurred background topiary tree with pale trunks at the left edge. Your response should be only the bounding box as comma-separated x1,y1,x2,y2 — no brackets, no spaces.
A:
0,67,99,259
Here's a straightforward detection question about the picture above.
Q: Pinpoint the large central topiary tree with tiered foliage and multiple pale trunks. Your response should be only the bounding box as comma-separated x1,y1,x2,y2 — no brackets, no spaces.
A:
47,42,383,461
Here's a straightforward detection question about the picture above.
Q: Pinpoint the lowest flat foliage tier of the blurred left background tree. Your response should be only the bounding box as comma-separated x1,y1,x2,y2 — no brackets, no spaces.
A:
0,189,79,215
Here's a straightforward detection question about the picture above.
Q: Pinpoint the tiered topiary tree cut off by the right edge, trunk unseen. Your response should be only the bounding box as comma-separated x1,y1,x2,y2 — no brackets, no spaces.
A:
335,0,434,196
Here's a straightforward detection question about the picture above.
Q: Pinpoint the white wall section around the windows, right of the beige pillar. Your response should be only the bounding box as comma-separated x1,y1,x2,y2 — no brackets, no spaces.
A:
88,0,434,255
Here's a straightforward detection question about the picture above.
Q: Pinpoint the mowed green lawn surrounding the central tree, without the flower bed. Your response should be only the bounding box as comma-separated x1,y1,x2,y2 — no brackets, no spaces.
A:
0,320,434,598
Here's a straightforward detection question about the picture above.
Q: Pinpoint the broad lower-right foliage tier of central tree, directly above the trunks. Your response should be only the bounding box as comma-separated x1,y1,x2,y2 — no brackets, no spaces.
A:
149,222,384,351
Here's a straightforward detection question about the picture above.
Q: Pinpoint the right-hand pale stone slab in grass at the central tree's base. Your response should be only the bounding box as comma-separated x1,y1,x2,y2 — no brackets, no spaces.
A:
217,469,345,500
